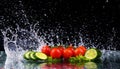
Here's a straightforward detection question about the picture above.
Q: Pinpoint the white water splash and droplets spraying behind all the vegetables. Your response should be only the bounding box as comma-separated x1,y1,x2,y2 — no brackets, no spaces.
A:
1,1,119,59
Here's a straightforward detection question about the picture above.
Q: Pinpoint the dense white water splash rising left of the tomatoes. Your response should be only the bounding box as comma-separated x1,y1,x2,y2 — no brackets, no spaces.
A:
3,26,45,58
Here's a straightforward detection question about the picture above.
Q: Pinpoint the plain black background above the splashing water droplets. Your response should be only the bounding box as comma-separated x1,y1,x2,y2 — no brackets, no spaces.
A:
0,0,120,50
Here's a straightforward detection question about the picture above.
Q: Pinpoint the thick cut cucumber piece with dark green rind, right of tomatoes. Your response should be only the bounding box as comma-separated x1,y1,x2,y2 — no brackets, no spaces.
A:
85,48,101,60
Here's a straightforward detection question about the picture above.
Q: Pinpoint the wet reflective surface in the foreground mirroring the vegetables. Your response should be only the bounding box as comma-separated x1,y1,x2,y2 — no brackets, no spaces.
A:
0,51,120,69
